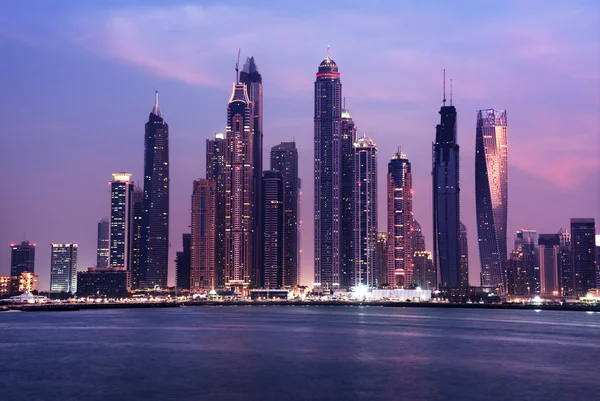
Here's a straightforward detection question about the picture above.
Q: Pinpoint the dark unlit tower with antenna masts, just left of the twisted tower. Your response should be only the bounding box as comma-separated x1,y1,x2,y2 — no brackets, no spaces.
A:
431,84,463,289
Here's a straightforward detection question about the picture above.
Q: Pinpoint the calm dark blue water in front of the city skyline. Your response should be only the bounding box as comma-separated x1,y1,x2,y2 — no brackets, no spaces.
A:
0,306,600,401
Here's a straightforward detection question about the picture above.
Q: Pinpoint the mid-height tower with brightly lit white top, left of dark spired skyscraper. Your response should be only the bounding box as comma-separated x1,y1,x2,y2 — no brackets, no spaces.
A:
108,173,134,271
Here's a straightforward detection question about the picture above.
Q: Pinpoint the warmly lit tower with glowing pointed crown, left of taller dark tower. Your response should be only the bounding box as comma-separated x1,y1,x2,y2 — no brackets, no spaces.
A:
225,82,254,293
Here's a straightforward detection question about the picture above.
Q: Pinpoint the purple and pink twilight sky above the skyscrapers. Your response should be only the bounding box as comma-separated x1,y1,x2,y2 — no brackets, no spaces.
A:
0,0,600,289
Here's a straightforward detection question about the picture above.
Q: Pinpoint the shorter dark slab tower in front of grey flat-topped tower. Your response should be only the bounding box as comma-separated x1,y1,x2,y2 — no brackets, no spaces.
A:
261,170,285,289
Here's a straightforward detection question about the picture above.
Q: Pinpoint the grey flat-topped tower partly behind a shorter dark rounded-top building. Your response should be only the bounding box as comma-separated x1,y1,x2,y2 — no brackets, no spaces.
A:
271,142,300,287
